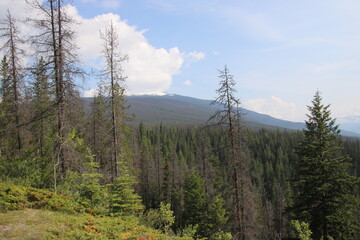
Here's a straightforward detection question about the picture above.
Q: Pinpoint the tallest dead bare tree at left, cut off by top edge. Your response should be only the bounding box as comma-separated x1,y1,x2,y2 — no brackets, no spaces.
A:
26,0,83,179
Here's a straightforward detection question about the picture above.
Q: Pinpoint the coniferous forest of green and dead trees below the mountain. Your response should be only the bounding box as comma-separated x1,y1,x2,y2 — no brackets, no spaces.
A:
0,0,360,240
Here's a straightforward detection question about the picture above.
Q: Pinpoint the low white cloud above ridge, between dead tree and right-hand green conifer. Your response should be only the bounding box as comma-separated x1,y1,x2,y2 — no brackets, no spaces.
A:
244,96,305,121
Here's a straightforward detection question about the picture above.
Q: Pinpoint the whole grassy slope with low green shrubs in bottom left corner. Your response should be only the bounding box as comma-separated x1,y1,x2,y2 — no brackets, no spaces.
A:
0,182,192,240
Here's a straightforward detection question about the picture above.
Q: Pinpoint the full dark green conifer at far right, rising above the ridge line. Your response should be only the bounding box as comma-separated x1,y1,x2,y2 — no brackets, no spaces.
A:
294,91,359,240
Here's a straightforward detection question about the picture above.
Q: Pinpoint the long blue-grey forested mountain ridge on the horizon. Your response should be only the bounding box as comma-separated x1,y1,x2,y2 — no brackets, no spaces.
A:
82,95,360,137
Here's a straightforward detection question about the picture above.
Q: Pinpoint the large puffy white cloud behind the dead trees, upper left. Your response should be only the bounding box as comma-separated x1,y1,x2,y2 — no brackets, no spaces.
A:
0,0,201,94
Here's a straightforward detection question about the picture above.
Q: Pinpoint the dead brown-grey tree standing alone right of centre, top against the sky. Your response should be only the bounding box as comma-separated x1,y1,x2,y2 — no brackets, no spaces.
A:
209,66,256,240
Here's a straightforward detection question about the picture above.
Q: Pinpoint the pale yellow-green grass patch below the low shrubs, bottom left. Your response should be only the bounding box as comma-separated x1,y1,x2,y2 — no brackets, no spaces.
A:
0,209,170,240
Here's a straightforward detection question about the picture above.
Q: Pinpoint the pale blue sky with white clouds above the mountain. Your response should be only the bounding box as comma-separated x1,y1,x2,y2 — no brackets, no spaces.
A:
0,0,360,129
